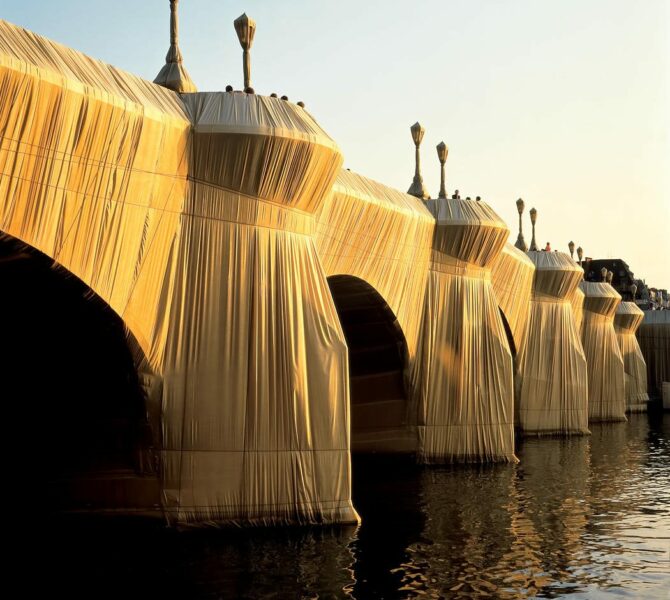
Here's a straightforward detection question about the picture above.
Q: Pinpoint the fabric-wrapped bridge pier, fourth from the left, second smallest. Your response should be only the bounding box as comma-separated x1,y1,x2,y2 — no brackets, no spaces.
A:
580,281,626,421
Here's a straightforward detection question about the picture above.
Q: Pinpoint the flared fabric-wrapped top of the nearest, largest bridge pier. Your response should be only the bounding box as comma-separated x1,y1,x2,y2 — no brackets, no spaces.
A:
182,92,342,218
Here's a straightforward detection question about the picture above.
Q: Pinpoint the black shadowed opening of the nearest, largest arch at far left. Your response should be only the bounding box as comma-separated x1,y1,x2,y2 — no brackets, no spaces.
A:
0,232,159,511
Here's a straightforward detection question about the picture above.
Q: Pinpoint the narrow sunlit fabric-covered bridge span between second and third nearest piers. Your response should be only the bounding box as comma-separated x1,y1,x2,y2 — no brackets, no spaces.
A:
491,243,535,352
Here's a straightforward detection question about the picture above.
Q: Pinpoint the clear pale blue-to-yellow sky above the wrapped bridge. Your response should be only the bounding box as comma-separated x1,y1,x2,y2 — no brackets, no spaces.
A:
0,0,670,288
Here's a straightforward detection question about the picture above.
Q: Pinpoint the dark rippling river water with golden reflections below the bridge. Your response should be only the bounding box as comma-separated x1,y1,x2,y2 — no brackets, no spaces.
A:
29,414,670,599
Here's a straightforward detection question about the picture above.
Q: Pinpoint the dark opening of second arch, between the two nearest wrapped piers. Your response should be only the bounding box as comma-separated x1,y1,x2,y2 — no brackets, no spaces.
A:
328,275,416,453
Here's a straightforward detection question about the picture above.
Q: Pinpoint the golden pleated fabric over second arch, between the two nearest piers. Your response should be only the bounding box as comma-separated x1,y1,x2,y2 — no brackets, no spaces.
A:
314,170,435,365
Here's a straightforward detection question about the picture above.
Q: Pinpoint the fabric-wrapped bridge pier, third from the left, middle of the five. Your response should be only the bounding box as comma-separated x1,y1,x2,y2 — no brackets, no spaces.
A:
515,252,588,434
